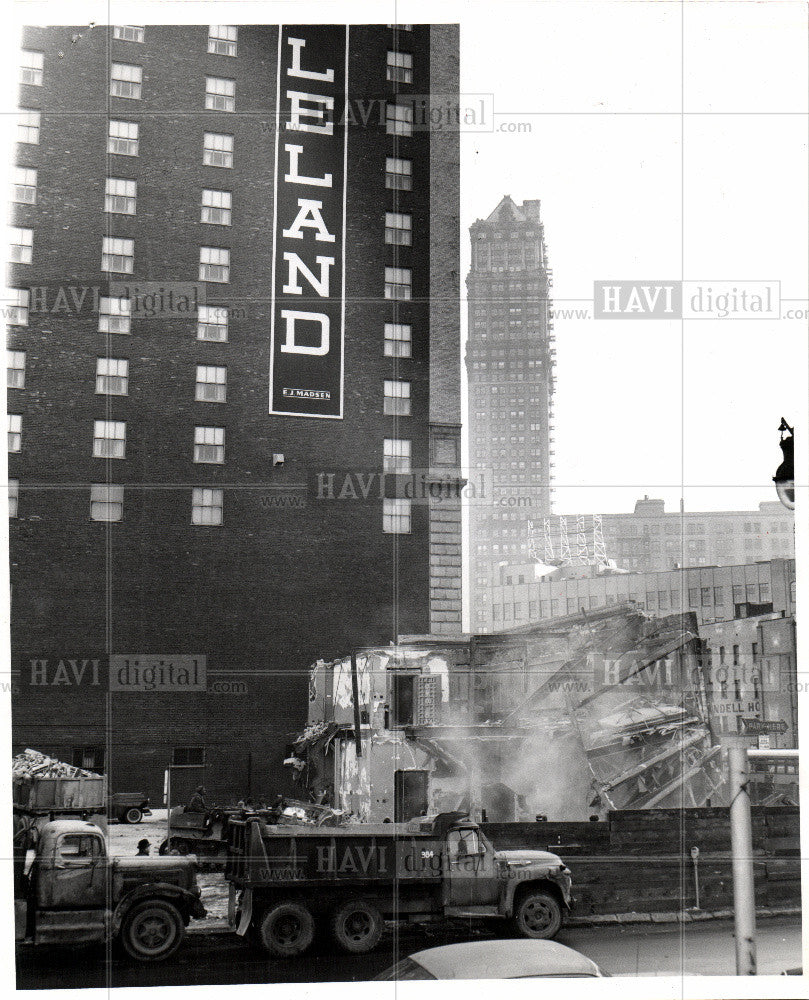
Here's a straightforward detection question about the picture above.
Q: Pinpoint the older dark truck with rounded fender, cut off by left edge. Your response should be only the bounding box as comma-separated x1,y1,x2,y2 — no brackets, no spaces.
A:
14,819,205,962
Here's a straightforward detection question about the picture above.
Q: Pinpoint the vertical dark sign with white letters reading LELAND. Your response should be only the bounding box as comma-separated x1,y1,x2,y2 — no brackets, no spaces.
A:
270,24,348,419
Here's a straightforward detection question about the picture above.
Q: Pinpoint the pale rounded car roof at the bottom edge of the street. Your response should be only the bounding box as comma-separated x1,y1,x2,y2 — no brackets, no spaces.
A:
410,938,601,979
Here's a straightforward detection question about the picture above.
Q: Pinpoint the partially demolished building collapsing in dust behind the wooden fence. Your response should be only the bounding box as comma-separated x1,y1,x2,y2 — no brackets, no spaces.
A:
286,604,723,822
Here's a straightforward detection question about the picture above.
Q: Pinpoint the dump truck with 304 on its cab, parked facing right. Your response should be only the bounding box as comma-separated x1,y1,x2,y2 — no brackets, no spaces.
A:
225,812,572,957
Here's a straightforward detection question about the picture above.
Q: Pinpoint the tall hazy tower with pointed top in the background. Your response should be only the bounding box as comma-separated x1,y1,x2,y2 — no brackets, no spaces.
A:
466,196,555,631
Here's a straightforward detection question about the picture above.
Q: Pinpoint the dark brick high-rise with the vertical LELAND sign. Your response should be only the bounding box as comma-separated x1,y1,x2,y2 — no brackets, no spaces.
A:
8,25,461,801
